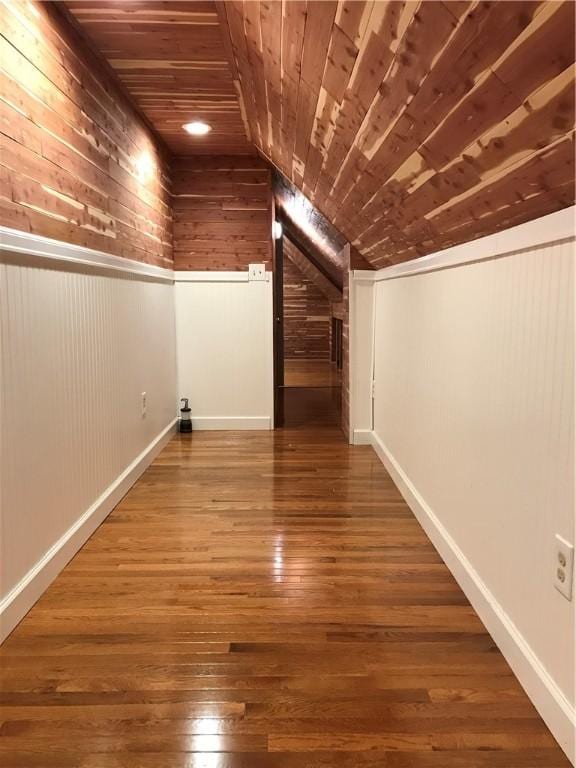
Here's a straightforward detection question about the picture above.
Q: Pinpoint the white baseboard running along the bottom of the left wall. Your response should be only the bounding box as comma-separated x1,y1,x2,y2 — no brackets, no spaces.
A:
0,419,177,642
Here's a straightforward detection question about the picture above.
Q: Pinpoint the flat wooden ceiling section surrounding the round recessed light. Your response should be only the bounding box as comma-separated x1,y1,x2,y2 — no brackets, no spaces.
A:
63,0,254,155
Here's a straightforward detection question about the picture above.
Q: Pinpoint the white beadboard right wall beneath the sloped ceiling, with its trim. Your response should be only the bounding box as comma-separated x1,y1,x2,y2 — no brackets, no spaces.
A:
366,210,576,759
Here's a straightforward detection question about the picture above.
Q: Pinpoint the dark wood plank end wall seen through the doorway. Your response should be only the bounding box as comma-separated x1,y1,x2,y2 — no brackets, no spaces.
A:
284,243,331,360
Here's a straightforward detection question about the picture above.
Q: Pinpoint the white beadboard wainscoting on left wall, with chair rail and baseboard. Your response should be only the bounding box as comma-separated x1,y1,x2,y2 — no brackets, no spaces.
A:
0,236,176,638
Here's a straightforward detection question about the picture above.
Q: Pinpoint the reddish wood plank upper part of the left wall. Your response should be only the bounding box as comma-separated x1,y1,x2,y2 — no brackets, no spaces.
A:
0,0,172,266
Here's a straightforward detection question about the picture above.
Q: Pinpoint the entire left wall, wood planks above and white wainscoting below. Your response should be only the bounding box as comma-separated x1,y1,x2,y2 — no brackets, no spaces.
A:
0,0,176,637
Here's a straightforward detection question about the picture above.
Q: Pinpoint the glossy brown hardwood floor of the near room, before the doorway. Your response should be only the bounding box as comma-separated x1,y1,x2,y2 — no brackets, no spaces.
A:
0,427,569,768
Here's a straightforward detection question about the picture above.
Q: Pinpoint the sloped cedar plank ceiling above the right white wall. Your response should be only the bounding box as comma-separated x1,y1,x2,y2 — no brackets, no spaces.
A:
225,0,575,267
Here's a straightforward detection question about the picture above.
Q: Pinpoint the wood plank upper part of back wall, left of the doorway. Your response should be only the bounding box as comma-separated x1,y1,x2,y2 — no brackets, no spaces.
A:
172,155,273,270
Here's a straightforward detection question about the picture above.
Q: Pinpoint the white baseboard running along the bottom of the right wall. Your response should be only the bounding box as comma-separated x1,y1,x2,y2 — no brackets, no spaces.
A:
370,432,576,764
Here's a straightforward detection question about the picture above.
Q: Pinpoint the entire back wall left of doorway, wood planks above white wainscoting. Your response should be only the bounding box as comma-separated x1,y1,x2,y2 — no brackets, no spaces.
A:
172,155,273,429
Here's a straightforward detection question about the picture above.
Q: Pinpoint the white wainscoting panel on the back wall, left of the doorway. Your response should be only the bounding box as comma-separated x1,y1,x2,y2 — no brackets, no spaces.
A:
175,272,274,429
